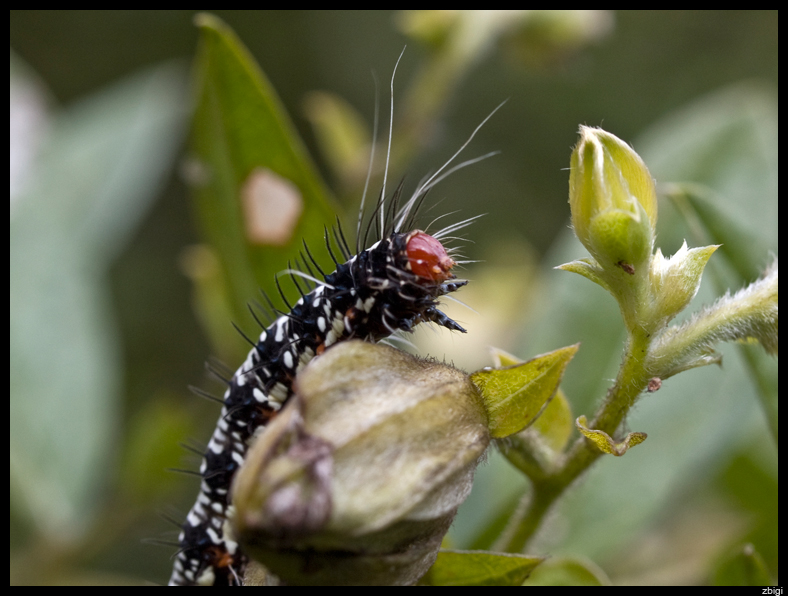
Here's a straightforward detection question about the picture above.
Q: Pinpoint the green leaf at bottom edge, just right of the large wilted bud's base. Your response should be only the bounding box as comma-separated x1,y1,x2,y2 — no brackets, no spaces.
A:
419,550,544,586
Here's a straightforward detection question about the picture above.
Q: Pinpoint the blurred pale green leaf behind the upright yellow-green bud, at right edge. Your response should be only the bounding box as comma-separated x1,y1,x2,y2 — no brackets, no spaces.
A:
637,82,779,254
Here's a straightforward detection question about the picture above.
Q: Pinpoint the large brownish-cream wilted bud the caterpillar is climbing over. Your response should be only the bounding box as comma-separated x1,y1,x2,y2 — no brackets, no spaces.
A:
233,342,490,585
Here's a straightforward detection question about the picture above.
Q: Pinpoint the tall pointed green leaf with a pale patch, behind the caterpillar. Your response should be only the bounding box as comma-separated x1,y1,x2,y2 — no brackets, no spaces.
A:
190,14,334,332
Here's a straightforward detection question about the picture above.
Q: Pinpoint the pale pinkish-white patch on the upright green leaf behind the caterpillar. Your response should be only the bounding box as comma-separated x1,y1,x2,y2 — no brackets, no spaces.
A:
241,168,304,246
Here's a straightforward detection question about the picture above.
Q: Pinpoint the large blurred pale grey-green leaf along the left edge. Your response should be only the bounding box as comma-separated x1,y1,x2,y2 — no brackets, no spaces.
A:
10,59,184,541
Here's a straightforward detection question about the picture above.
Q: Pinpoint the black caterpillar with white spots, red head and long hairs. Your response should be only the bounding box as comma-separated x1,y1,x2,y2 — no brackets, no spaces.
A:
169,61,500,586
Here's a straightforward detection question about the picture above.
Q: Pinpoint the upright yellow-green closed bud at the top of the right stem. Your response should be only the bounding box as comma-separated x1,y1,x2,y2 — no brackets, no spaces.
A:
569,126,657,274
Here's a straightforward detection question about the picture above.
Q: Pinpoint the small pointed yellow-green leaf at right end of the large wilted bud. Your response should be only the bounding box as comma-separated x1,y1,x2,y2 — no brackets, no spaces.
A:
471,344,579,439
